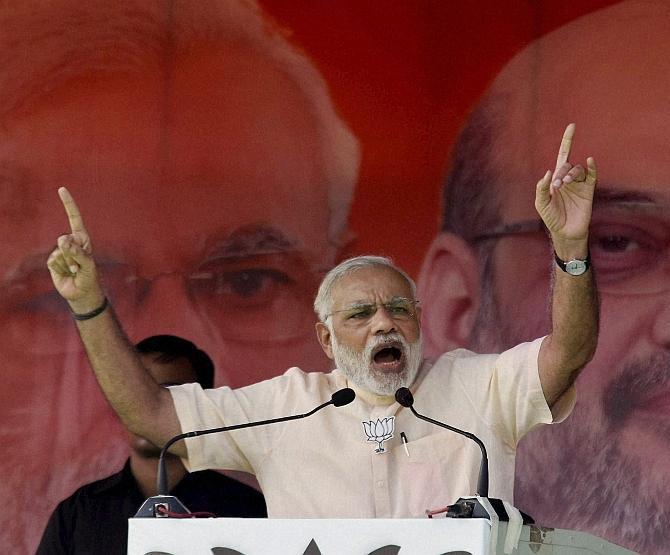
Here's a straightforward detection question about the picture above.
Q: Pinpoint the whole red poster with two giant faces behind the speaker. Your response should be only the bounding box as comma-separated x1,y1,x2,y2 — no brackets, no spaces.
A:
0,0,670,553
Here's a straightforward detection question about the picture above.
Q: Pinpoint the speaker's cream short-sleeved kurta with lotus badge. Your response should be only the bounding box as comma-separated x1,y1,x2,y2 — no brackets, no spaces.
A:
170,339,574,518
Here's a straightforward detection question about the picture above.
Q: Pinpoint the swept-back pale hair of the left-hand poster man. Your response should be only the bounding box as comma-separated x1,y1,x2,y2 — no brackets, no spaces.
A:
0,0,361,244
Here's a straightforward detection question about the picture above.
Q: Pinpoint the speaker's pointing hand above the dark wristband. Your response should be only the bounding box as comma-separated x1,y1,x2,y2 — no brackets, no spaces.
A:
47,187,105,314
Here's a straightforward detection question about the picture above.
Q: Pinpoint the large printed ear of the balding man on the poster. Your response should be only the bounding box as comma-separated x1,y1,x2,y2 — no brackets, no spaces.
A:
418,233,481,357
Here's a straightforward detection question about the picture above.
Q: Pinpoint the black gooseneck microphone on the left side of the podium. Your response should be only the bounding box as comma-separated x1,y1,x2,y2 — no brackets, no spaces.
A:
135,387,356,518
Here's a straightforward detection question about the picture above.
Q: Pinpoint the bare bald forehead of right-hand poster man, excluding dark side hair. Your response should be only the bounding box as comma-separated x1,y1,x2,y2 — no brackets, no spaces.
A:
489,0,670,193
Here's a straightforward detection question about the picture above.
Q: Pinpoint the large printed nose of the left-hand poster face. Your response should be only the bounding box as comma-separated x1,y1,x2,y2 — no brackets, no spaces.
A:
119,274,213,344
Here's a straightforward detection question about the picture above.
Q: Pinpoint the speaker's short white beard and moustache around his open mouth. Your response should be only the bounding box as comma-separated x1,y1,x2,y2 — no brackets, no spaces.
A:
331,332,423,395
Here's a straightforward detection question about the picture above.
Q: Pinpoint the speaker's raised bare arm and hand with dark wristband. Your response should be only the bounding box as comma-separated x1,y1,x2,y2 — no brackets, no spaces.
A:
47,187,186,456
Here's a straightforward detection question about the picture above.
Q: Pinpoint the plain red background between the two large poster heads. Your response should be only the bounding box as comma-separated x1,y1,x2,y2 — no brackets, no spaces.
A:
263,0,612,273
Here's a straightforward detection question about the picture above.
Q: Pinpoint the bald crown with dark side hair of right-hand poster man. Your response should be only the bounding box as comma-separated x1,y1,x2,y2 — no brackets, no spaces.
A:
443,0,670,238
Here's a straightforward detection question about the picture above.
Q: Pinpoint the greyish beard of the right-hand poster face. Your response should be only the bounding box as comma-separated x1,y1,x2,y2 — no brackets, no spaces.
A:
515,365,670,555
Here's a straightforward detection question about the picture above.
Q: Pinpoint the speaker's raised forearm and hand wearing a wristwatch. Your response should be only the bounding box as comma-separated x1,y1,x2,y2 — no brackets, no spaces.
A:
535,123,598,406
